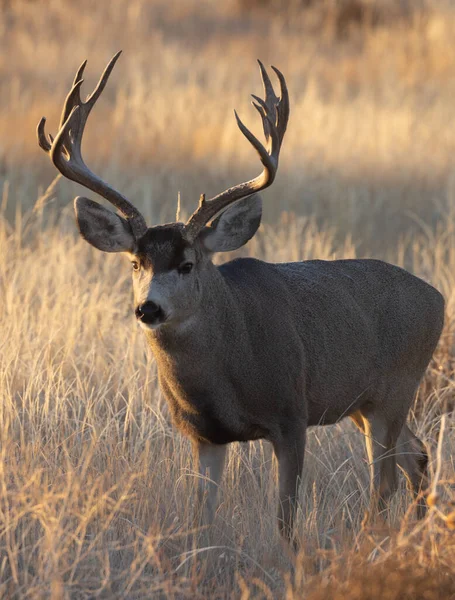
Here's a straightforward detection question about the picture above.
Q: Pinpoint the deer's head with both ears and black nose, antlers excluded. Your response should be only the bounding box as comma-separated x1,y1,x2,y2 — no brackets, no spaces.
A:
75,195,262,329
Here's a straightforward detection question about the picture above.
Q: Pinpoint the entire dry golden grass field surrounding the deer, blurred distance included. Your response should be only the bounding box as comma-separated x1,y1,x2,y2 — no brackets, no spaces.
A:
0,0,455,600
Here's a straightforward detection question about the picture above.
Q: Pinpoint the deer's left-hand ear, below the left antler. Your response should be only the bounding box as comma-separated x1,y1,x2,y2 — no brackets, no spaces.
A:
74,196,135,252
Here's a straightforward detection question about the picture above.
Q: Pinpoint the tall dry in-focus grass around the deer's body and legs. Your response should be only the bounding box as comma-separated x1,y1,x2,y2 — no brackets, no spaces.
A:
0,199,455,598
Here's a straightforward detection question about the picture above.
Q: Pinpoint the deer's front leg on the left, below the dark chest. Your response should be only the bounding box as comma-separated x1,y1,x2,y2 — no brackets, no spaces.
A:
193,441,227,526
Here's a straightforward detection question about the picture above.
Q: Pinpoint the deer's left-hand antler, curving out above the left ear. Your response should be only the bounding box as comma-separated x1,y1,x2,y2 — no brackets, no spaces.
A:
37,52,147,238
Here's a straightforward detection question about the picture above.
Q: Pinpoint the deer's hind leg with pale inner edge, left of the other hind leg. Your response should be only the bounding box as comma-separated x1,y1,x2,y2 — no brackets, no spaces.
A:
363,413,402,513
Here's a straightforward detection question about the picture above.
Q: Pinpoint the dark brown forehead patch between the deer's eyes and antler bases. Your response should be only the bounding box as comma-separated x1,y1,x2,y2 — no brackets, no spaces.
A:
135,224,195,273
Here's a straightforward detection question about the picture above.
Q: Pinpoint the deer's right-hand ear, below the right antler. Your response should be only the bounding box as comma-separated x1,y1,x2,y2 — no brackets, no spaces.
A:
199,194,262,252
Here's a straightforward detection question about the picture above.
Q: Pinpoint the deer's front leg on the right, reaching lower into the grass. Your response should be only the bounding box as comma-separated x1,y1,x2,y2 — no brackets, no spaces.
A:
273,425,306,542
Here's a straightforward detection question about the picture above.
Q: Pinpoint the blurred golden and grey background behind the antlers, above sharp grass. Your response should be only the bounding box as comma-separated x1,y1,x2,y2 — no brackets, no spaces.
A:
0,0,455,257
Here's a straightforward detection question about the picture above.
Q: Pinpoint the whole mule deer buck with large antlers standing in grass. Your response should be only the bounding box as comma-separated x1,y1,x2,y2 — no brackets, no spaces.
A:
37,53,444,539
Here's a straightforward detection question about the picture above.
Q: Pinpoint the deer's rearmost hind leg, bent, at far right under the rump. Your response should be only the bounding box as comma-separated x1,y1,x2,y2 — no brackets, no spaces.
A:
397,424,428,519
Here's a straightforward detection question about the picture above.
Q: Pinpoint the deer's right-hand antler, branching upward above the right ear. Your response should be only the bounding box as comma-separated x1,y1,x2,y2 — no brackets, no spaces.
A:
185,60,289,242
